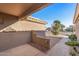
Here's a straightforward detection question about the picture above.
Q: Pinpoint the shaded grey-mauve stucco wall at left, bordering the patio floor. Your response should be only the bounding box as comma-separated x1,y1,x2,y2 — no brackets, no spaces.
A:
0,31,31,51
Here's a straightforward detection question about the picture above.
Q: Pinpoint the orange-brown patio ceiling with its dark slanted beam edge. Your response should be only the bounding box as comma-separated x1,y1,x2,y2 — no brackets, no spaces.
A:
0,3,48,17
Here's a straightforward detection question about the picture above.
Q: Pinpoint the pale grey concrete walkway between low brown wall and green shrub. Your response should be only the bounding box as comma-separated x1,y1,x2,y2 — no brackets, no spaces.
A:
47,38,69,56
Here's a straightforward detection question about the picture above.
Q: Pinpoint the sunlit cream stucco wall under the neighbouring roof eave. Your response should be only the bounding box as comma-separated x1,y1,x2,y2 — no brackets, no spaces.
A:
4,20,46,31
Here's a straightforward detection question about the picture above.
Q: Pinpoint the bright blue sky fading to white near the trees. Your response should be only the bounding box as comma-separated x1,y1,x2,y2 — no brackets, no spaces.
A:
32,3,76,27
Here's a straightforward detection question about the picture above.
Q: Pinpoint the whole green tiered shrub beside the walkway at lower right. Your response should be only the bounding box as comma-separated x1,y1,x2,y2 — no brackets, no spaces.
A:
65,34,79,56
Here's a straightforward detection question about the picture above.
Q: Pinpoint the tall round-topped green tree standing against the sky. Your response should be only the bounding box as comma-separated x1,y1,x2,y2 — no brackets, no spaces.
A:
52,20,61,35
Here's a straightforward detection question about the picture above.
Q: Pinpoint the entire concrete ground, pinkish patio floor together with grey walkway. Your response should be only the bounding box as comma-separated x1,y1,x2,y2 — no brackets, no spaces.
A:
0,38,69,56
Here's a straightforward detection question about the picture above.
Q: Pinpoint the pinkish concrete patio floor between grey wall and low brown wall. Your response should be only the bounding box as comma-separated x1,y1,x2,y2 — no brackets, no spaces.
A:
0,44,45,56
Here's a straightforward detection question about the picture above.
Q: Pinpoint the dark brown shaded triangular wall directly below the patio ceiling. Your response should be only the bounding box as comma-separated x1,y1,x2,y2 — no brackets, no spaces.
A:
0,13,18,32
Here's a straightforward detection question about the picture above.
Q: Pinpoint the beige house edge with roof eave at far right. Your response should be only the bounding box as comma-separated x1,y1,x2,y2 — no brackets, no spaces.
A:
73,4,79,40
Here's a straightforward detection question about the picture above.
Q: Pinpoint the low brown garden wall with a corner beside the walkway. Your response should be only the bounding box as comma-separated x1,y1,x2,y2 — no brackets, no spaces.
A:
32,31,62,49
